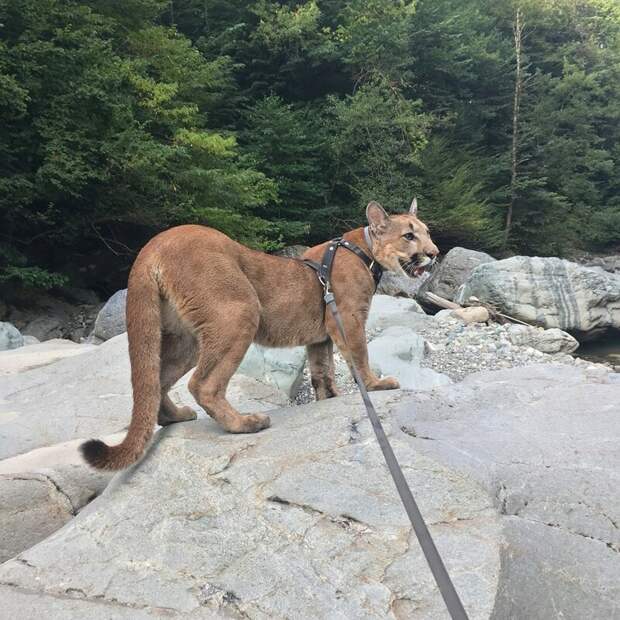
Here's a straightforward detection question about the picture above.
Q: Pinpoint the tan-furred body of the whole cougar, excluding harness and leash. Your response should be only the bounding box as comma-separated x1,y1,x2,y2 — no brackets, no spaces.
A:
82,203,438,469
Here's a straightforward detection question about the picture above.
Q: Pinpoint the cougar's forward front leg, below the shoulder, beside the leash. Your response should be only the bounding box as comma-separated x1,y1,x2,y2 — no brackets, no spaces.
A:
326,307,400,391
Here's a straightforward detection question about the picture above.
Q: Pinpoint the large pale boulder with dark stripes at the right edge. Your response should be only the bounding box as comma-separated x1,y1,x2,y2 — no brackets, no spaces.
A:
456,256,620,337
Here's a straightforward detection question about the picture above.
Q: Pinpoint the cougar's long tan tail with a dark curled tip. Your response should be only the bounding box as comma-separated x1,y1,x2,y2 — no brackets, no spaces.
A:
80,265,161,470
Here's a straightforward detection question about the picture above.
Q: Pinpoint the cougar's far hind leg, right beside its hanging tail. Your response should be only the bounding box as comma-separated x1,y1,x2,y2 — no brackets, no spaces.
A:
157,332,196,426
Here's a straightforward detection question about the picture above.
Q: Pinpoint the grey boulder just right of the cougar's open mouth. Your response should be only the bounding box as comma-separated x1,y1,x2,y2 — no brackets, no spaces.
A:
417,248,495,302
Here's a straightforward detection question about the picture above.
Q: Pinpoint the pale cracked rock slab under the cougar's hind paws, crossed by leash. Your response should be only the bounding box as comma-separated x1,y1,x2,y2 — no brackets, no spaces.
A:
0,392,501,620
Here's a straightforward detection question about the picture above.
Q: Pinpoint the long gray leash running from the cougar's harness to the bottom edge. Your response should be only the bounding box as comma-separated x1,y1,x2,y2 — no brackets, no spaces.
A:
324,290,468,620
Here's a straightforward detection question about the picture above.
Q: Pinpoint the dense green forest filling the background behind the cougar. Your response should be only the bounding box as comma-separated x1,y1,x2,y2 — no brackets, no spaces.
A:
0,0,620,288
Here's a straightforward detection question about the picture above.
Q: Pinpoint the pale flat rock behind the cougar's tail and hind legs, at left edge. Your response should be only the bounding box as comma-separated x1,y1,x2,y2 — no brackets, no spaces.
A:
0,334,288,459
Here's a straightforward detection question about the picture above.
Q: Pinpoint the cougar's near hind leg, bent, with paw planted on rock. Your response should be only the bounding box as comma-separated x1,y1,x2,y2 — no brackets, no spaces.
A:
189,302,270,433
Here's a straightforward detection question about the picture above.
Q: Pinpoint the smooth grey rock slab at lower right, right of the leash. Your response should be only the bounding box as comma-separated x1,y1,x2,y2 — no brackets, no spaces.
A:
396,365,620,620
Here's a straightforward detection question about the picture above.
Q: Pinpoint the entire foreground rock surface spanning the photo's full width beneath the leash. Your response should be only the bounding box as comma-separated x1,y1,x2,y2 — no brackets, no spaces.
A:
0,365,620,620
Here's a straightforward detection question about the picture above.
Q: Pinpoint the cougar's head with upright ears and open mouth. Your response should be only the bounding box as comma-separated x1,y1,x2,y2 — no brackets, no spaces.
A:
366,198,439,278
